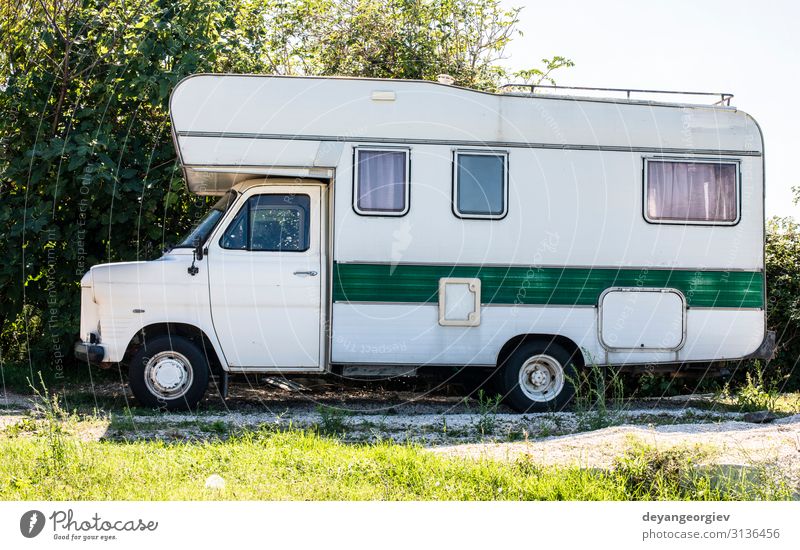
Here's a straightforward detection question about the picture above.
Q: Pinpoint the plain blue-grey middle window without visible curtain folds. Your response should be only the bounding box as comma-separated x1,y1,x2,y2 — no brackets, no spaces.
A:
453,152,508,219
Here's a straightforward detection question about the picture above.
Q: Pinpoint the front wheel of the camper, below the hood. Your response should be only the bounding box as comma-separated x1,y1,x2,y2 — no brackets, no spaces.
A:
128,336,209,411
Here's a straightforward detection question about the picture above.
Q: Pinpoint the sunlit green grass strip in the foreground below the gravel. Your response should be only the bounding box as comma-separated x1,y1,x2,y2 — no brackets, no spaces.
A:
0,429,789,500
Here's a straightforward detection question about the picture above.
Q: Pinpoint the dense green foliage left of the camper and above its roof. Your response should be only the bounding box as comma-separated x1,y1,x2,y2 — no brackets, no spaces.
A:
0,0,562,382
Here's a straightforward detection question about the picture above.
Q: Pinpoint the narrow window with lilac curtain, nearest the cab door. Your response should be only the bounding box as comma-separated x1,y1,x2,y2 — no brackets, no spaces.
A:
355,148,409,216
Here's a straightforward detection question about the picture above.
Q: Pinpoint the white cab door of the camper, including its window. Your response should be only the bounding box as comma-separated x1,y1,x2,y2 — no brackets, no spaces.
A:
207,185,325,371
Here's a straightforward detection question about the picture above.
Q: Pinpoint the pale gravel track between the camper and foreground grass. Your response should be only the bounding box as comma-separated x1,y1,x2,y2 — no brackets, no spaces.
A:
0,381,800,494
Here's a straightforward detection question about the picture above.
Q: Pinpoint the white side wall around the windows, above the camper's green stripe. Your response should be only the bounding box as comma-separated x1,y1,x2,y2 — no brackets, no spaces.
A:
334,149,764,271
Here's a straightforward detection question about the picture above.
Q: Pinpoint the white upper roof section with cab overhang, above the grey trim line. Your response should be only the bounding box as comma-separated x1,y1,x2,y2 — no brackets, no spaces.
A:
170,75,761,160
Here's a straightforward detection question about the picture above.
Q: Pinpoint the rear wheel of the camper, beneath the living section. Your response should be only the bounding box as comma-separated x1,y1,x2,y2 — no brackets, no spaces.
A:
498,340,577,412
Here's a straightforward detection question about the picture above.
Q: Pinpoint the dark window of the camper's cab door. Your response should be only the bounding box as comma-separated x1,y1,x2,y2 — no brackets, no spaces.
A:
220,195,311,252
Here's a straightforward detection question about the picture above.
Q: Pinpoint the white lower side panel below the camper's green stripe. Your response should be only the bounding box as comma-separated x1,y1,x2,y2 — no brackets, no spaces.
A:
331,303,764,367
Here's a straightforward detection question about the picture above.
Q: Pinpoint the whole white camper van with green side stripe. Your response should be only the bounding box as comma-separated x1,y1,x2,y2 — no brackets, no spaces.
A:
76,75,771,410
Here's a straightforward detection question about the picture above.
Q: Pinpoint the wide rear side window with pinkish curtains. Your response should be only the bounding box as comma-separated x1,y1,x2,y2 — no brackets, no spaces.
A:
646,160,739,224
